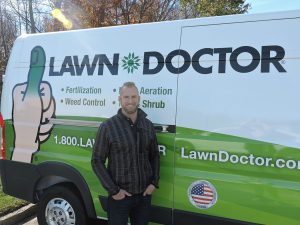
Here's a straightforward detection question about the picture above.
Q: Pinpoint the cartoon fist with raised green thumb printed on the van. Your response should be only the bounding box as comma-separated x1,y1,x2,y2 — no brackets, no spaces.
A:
12,46,55,162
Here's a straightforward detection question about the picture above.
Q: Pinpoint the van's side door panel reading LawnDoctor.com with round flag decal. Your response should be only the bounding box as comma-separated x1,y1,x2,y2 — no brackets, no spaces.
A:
174,14,300,225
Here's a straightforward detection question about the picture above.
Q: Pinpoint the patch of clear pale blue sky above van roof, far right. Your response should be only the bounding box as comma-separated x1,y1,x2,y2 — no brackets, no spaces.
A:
246,0,300,13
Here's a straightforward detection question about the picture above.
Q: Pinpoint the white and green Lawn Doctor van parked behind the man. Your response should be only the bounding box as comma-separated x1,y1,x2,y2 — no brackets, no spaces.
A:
0,11,300,225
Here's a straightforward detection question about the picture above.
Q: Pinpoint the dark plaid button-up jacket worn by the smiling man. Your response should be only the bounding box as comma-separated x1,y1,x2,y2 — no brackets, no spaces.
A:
92,109,159,195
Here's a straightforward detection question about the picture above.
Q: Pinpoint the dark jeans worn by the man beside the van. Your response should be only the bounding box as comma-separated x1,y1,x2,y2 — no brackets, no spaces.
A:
107,194,151,225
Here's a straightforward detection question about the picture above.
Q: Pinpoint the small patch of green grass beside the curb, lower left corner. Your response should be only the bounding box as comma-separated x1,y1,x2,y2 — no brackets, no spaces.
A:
0,182,28,216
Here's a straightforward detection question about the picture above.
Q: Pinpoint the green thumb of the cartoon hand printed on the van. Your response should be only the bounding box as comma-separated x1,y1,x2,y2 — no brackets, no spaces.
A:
24,46,46,97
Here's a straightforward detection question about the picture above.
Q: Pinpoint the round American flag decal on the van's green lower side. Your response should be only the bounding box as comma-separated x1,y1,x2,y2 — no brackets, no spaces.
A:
188,180,217,209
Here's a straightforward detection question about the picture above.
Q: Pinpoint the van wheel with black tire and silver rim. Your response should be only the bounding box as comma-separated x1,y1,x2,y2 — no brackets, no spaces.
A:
37,186,86,225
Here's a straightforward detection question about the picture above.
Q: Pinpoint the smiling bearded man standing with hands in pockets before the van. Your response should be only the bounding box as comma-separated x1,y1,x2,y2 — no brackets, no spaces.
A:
92,82,159,225
